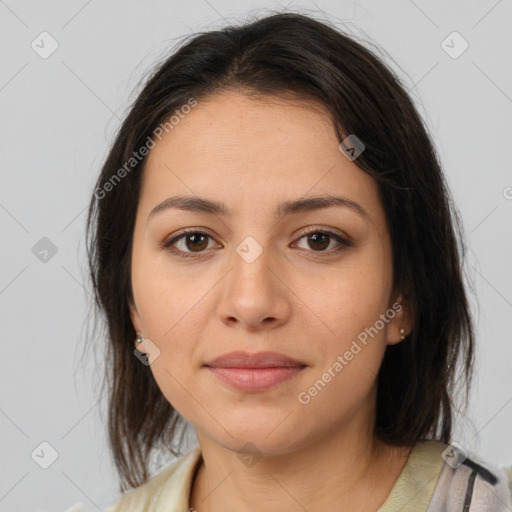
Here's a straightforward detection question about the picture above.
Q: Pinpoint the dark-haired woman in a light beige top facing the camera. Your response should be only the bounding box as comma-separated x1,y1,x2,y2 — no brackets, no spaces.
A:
88,13,512,512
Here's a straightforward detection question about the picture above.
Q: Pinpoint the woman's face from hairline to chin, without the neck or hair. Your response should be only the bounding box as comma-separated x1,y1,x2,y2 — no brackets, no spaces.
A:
131,92,409,454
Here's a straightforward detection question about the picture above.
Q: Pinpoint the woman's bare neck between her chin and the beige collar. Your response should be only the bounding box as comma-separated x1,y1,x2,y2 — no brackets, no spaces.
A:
190,423,410,512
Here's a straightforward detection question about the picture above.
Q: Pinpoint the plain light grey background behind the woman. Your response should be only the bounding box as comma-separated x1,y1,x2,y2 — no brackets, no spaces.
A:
0,0,512,511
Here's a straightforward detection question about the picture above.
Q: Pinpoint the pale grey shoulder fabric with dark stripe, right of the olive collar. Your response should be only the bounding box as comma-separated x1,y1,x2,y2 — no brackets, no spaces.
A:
428,443,512,512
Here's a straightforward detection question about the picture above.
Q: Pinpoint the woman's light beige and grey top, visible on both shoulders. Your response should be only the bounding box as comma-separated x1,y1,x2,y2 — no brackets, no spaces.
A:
96,441,512,512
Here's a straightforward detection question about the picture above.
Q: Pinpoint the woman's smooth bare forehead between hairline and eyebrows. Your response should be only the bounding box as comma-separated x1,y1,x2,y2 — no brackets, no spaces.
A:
142,91,382,226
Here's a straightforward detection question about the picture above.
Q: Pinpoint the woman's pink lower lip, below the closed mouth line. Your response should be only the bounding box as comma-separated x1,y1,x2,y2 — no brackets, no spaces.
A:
207,366,304,392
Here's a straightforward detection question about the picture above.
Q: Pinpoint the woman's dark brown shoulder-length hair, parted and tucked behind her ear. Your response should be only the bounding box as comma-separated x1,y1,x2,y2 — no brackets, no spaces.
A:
87,13,474,491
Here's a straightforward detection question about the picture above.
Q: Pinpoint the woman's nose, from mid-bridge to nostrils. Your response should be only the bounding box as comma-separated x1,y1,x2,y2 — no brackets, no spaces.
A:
217,237,291,332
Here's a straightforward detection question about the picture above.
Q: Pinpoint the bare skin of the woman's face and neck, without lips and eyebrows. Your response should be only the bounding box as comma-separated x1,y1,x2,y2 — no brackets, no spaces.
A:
131,91,411,512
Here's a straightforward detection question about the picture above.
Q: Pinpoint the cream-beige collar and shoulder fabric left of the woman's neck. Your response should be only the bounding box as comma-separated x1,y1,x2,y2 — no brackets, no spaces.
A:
105,447,201,512
